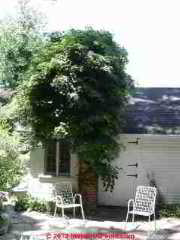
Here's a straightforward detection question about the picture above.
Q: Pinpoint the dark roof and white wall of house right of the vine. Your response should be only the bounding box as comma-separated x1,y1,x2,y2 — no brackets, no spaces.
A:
98,88,180,206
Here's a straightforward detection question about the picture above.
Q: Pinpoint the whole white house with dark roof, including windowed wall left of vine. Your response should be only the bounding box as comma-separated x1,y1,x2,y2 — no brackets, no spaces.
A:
28,88,180,206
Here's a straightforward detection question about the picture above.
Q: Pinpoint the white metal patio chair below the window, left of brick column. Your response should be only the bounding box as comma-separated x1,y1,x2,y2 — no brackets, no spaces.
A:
54,182,85,219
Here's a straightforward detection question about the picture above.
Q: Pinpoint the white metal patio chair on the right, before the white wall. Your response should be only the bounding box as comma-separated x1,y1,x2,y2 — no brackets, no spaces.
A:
126,186,157,228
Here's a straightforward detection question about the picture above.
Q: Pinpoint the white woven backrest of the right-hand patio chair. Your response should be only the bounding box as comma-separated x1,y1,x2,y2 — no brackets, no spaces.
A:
134,186,157,213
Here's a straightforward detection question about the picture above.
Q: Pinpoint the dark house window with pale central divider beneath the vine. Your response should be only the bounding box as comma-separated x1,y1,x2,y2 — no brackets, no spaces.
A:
45,140,71,176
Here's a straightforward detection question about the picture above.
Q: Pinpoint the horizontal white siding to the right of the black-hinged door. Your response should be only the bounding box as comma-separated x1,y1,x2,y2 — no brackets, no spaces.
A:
141,136,180,203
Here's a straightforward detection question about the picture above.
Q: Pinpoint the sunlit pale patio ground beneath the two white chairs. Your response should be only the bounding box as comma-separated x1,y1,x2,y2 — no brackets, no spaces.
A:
0,207,180,240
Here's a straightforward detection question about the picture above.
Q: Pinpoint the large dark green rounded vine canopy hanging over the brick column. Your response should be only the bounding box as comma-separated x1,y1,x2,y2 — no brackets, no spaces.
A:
18,28,133,189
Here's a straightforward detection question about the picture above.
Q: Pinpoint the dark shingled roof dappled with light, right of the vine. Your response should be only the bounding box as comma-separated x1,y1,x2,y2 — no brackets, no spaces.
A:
124,88,180,134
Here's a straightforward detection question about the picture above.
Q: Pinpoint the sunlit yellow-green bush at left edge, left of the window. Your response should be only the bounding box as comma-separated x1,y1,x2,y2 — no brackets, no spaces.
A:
0,122,24,191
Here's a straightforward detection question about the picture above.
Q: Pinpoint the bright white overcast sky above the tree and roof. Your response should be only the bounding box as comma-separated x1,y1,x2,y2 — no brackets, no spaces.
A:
0,0,180,87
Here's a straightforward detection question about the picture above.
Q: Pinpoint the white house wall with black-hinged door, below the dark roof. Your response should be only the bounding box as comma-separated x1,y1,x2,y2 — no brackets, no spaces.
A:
98,134,180,206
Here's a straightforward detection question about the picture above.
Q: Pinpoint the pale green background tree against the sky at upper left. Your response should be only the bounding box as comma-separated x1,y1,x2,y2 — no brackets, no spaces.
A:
0,0,45,89
